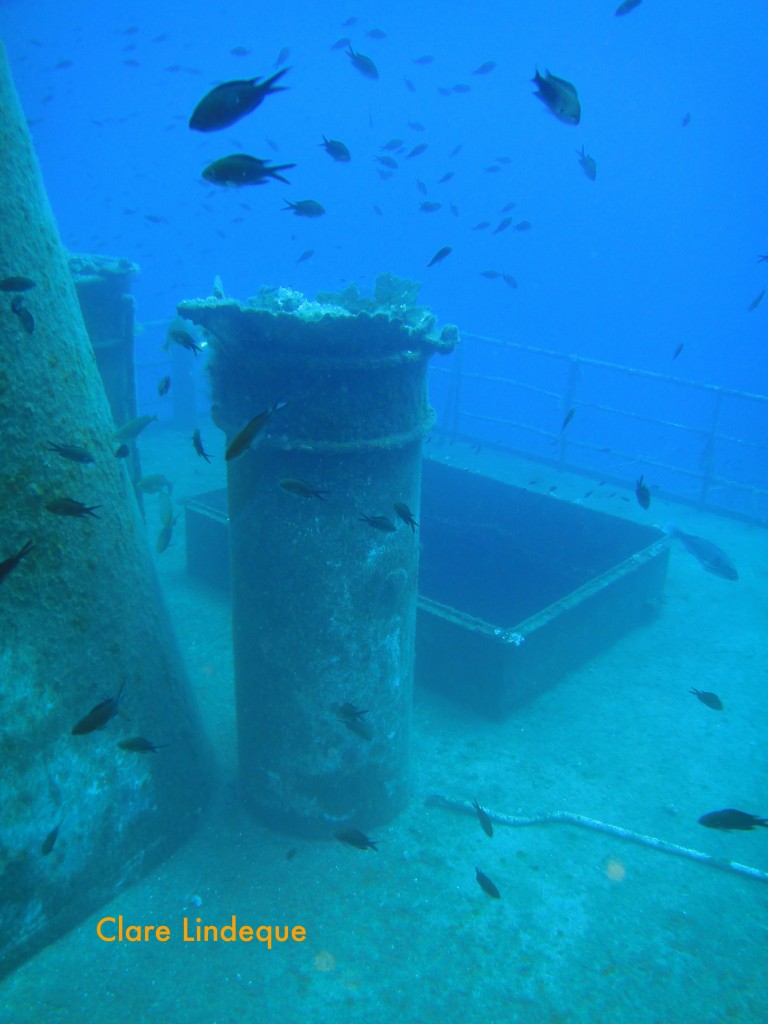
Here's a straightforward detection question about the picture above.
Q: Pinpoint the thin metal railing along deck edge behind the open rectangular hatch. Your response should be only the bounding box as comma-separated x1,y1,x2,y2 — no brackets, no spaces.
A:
430,334,768,523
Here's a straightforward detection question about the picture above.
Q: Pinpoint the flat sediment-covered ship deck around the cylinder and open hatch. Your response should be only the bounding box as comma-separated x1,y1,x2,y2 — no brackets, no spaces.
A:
0,431,768,1024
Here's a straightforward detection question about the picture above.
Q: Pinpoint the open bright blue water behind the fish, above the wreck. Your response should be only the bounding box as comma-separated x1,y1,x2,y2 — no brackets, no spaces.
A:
2,2,768,518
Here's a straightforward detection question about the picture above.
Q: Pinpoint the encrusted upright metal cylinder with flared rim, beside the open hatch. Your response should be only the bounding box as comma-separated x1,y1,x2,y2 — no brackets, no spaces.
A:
179,289,457,835
